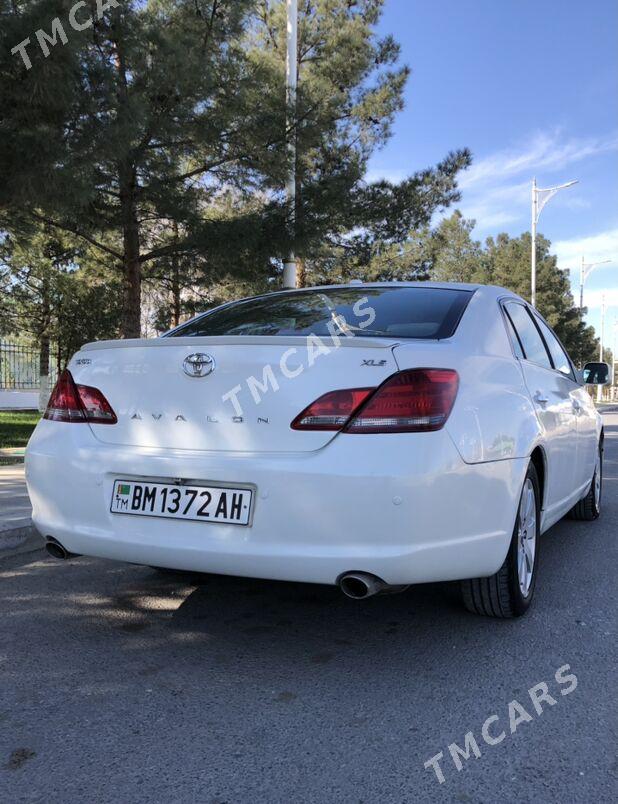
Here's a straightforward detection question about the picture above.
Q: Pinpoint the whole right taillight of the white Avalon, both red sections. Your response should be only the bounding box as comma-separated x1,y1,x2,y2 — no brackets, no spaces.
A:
291,369,459,433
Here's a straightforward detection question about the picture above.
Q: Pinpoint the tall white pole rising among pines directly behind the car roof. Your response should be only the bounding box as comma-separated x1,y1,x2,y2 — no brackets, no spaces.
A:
283,0,298,288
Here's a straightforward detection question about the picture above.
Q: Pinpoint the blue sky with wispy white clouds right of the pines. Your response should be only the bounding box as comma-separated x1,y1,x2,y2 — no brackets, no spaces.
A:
370,0,618,346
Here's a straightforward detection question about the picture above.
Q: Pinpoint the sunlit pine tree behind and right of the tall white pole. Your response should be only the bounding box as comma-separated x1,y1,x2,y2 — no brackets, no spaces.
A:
250,0,470,274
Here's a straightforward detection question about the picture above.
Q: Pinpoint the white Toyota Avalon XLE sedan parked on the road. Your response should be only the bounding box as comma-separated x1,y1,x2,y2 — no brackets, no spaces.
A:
26,283,609,617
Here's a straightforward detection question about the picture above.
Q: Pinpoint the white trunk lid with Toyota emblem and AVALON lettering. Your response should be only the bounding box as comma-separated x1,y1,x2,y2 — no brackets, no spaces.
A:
69,336,397,452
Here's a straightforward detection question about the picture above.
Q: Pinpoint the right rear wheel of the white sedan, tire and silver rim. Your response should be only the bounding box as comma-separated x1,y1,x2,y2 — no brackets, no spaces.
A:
461,463,541,619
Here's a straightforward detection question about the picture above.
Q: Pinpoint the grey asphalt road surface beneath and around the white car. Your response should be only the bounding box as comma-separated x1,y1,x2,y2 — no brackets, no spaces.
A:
0,414,618,804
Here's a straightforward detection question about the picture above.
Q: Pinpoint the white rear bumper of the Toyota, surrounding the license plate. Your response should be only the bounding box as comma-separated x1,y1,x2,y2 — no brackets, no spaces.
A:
26,421,527,584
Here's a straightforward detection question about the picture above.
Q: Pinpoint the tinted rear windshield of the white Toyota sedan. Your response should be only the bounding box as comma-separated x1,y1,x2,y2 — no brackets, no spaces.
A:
166,287,472,339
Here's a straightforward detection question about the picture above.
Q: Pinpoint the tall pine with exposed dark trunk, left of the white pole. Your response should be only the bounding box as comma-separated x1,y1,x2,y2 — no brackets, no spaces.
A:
3,0,285,337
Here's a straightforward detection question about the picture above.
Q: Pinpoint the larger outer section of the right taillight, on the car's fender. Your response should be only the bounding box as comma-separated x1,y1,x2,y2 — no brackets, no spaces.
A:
345,369,459,433
